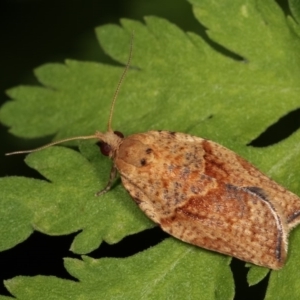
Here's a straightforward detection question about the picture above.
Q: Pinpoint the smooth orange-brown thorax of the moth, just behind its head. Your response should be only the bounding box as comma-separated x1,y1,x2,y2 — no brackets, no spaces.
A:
118,137,154,168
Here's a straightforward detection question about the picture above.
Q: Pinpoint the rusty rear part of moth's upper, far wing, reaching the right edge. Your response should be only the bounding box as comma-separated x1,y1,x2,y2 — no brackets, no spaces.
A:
202,140,300,230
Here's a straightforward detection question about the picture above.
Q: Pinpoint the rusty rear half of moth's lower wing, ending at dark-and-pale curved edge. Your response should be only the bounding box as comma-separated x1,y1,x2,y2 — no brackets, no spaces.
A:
160,183,287,269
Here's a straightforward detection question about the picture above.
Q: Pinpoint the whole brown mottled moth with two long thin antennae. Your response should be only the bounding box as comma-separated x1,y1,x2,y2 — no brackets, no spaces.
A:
7,35,300,269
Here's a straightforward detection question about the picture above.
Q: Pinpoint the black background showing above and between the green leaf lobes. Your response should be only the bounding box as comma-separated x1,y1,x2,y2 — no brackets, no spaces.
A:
0,0,300,300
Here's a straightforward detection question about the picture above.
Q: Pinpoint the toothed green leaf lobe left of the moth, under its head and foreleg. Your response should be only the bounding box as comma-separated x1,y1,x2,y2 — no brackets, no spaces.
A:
0,146,153,253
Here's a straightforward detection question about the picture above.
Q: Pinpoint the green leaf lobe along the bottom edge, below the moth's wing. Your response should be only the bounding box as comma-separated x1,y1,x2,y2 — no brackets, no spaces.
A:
5,239,234,300
